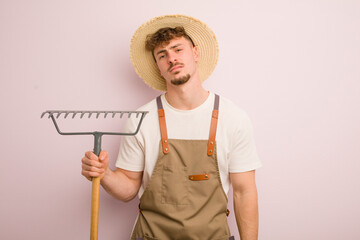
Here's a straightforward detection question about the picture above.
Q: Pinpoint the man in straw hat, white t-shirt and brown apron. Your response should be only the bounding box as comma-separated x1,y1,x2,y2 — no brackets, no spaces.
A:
82,15,261,240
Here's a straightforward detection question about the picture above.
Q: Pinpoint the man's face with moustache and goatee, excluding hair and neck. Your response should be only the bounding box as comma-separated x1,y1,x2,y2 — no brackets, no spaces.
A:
154,37,199,85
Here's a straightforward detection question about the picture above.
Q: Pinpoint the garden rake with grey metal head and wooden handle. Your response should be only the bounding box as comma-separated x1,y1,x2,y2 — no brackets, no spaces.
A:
41,110,148,240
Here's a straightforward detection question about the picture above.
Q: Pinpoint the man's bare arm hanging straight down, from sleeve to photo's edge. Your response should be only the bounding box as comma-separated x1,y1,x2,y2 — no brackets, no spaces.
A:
230,170,259,240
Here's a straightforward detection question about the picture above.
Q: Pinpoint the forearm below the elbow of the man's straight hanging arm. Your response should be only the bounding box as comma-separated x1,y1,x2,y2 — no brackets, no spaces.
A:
234,188,259,240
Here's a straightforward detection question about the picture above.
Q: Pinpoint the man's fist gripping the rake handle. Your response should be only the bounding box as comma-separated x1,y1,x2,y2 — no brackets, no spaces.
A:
81,151,109,181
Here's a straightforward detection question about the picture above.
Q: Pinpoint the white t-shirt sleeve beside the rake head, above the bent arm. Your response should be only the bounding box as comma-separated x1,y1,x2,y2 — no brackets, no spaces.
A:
115,118,145,172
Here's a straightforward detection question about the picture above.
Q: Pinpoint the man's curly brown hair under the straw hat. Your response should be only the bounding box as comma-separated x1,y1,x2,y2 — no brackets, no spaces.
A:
145,26,195,53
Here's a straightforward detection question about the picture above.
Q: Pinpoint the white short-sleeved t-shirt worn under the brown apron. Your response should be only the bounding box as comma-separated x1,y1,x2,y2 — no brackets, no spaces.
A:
116,93,261,197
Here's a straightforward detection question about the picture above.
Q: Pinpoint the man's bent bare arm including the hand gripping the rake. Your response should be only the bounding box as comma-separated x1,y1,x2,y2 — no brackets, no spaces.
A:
81,151,143,202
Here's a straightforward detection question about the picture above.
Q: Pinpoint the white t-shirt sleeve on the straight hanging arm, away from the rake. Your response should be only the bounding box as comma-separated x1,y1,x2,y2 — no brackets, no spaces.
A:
229,112,262,173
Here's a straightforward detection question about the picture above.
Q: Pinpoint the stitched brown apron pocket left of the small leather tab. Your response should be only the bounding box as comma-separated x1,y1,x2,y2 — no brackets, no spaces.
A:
161,166,189,205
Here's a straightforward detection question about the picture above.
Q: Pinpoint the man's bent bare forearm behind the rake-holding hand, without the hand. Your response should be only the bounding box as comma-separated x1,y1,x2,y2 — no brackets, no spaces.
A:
101,169,139,202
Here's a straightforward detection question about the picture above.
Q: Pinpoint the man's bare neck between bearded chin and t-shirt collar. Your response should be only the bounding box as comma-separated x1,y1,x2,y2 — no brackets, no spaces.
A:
165,74,209,110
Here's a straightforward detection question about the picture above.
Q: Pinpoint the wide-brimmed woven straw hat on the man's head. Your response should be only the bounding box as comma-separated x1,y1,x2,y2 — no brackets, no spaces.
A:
130,15,219,91
